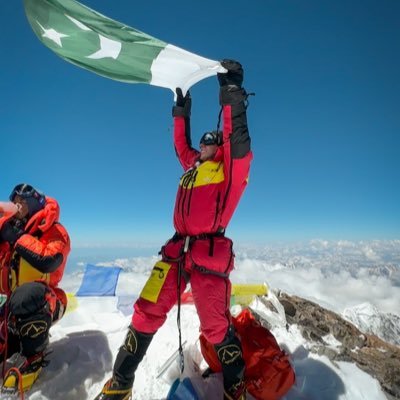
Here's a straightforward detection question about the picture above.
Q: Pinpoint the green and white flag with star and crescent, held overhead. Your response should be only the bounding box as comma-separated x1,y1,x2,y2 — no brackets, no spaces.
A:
24,0,226,93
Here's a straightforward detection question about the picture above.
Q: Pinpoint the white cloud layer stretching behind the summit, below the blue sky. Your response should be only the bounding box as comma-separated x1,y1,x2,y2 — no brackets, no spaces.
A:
63,240,400,314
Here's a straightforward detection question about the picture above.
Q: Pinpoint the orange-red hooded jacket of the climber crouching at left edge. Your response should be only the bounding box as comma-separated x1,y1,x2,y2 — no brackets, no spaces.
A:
0,197,71,294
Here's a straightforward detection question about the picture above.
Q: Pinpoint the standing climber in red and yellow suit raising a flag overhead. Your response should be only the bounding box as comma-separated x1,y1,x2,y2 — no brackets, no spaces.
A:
95,60,252,400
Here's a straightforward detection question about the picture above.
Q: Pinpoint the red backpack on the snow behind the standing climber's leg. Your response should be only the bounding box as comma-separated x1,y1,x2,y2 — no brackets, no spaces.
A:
200,309,295,400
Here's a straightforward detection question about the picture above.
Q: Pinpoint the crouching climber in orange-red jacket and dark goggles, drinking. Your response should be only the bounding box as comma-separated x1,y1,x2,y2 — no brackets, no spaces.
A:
0,183,71,395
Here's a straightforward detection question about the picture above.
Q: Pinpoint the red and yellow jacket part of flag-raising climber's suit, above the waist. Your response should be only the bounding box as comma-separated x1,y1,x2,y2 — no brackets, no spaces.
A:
174,88,253,236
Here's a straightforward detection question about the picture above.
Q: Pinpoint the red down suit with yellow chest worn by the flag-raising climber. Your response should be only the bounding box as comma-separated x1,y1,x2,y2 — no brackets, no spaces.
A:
132,87,252,343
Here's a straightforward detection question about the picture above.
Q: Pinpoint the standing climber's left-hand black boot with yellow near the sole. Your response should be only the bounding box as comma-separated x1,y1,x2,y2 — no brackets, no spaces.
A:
94,326,154,400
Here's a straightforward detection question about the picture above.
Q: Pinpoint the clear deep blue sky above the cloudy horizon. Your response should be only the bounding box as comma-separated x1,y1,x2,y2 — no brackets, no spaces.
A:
0,0,400,247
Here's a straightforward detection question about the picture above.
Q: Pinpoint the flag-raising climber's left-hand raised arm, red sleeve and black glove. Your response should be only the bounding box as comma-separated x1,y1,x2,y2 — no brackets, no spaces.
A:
172,88,199,171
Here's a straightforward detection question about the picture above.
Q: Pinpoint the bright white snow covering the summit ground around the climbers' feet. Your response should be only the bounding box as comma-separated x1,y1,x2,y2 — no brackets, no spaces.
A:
28,297,386,400
